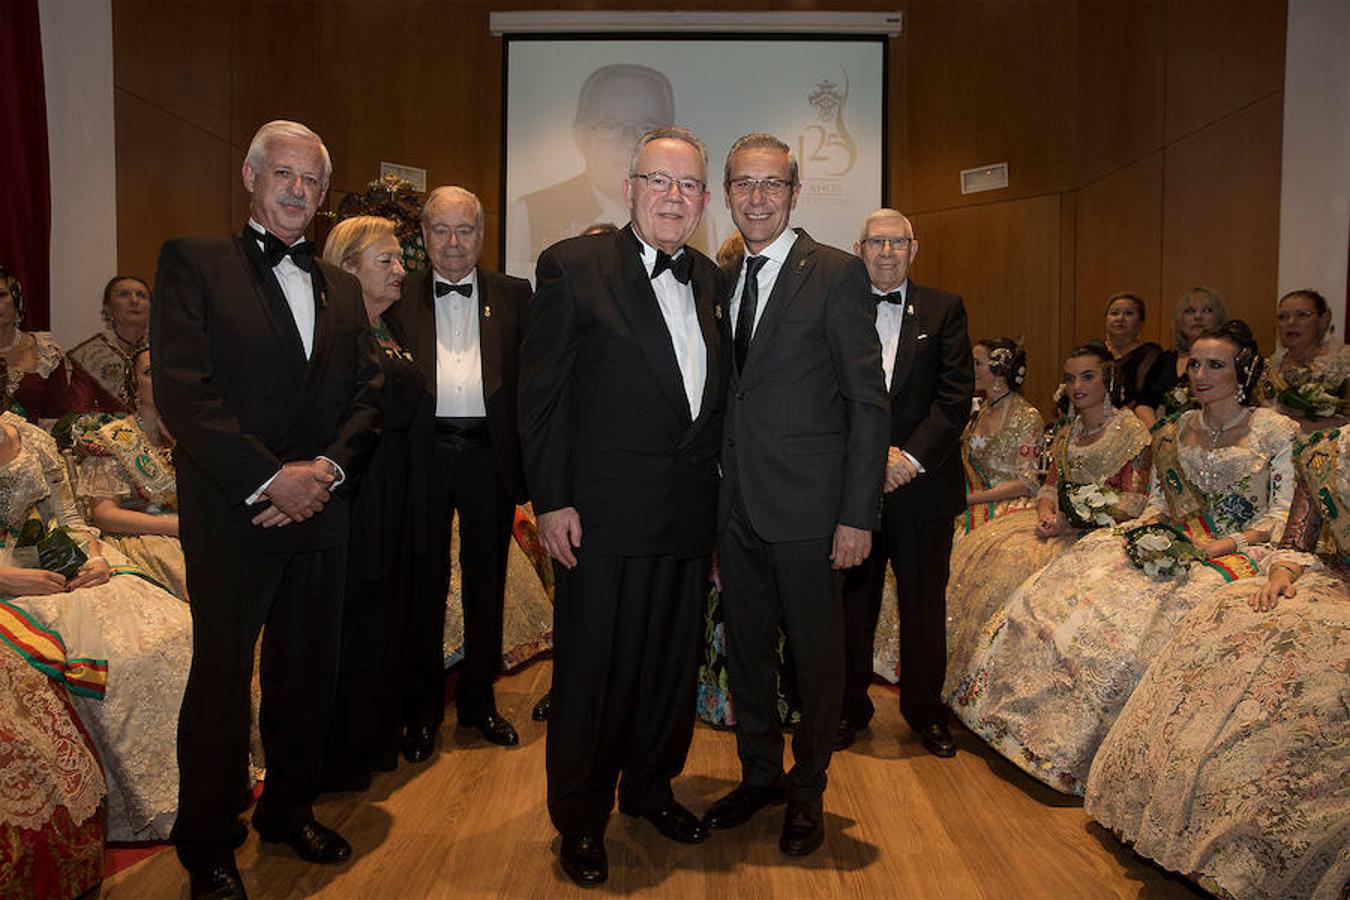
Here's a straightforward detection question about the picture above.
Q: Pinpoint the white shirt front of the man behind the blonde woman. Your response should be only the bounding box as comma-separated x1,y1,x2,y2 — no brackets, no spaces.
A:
432,267,487,418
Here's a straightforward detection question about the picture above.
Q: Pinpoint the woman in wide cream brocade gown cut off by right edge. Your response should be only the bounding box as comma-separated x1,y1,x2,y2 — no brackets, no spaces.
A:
1084,432,1350,897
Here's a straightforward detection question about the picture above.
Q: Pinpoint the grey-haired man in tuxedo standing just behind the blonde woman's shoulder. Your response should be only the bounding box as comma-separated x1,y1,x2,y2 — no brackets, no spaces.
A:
390,186,529,762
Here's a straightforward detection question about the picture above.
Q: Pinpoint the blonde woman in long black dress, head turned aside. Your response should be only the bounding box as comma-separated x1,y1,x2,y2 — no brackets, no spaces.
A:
323,216,428,791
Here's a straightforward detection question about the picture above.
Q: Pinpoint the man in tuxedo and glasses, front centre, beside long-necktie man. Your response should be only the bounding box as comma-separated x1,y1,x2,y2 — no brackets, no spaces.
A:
520,128,728,885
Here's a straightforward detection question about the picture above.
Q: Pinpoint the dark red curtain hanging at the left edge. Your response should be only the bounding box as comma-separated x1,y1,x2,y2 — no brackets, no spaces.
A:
0,0,51,331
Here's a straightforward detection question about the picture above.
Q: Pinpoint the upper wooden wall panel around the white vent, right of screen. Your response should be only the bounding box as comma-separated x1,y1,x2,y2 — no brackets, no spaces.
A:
906,0,1076,210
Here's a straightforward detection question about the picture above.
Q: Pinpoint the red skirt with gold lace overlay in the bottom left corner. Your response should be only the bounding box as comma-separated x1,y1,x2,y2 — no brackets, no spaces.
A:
0,639,108,900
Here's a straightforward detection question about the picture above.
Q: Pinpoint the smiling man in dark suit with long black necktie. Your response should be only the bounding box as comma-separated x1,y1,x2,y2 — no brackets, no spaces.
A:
705,134,888,855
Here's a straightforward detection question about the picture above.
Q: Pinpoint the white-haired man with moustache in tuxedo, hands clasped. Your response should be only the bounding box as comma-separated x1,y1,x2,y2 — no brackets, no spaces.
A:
150,121,381,897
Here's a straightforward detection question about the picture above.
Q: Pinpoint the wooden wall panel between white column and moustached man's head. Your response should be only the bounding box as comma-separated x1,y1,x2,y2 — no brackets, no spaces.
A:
117,89,238,279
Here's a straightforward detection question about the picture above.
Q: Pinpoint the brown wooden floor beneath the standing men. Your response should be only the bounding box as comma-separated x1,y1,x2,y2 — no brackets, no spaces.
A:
101,661,1203,900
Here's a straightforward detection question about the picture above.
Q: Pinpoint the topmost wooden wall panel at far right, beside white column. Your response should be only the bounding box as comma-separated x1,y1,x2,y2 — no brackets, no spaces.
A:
1166,0,1288,143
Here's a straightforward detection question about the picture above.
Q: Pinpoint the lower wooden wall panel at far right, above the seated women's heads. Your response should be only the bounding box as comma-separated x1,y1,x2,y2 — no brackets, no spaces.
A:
1162,93,1284,352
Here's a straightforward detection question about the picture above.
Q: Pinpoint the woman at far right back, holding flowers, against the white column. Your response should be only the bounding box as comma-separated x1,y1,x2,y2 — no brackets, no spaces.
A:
1261,290,1350,433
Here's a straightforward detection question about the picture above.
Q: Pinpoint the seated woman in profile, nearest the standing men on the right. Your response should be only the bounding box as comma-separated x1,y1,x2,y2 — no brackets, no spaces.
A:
956,337,1045,542
